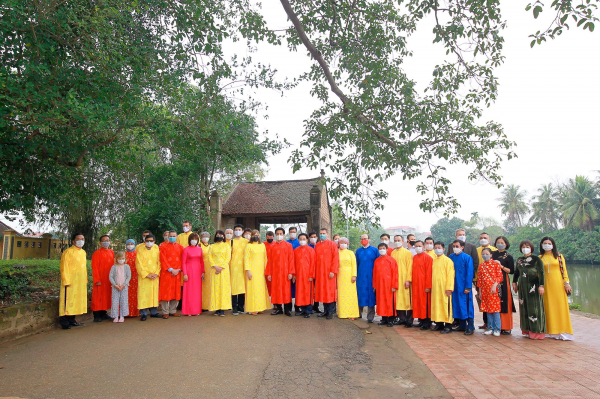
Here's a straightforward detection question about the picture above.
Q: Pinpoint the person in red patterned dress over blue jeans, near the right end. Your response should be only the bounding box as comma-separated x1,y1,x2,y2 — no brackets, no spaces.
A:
477,248,504,337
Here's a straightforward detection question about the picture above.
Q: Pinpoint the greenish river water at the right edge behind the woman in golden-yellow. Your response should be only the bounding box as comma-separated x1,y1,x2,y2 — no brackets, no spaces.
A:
567,264,600,315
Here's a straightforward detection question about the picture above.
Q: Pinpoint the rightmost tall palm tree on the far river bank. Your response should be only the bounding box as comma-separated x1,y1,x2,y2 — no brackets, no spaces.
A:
561,176,600,231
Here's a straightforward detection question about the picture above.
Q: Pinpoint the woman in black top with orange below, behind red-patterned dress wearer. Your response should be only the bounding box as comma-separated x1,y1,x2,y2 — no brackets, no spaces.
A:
492,236,517,335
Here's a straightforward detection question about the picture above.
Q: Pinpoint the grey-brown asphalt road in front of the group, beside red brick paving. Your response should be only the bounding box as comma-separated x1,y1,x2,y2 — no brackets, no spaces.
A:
0,314,449,399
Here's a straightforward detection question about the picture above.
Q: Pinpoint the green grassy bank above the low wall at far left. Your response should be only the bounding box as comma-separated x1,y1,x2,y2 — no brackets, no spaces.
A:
0,259,92,306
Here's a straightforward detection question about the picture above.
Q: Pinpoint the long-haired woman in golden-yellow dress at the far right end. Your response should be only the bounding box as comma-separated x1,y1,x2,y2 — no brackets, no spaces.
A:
540,237,573,341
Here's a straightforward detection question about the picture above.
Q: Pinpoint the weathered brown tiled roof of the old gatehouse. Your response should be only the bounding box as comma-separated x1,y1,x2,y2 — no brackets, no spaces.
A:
222,178,320,215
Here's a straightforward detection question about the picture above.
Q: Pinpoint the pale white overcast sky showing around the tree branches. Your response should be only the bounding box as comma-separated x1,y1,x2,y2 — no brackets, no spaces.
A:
245,0,600,231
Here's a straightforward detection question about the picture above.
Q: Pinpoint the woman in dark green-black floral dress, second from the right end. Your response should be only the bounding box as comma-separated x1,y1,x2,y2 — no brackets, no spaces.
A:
513,240,546,339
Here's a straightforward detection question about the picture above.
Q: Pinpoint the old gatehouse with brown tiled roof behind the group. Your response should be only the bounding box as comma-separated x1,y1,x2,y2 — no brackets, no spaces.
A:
210,171,332,232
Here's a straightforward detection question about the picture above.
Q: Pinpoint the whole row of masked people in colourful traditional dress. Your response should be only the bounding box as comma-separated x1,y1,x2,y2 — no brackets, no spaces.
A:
59,225,573,339
